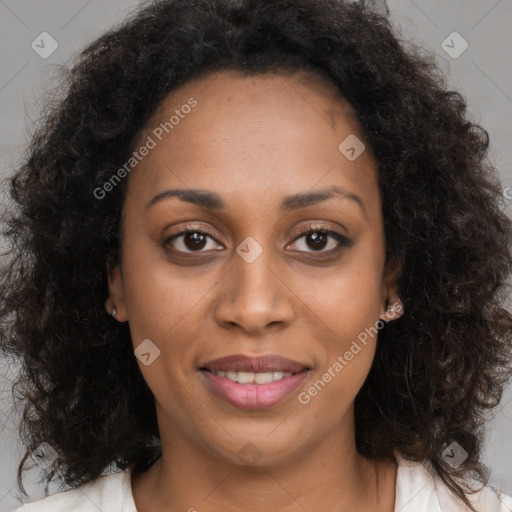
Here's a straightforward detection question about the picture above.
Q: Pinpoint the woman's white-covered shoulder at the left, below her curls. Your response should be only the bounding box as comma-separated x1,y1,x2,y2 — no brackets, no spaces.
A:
13,468,137,512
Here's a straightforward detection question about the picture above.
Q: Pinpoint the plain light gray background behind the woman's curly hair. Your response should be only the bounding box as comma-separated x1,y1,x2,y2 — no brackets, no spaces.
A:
0,0,512,512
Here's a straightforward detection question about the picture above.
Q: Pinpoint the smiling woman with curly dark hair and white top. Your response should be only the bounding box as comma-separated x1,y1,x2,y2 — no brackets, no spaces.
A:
1,0,512,512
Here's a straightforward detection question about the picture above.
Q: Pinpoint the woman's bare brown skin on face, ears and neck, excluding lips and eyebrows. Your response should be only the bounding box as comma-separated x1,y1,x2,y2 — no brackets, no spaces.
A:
105,71,404,512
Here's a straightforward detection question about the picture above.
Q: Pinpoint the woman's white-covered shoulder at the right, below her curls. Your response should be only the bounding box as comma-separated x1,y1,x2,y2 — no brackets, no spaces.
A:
395,457,512,512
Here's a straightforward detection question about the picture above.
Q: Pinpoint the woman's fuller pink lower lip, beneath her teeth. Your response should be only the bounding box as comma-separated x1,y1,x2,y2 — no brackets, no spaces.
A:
201,370,309,410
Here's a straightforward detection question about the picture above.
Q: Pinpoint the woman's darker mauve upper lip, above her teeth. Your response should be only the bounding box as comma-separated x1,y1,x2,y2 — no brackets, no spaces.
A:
200,354,308,373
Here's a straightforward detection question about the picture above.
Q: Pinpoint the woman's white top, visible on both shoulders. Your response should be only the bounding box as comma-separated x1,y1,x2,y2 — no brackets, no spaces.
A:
14,457,512,512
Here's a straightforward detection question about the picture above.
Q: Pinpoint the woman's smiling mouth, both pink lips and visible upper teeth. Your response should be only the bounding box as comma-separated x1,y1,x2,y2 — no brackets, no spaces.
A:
199,355,310,410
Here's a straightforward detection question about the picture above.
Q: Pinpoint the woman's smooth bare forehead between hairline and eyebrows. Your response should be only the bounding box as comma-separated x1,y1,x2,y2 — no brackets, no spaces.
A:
124,71,378,220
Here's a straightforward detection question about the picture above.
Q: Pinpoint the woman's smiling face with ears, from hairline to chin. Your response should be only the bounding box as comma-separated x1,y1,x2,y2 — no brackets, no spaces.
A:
106,72,396,464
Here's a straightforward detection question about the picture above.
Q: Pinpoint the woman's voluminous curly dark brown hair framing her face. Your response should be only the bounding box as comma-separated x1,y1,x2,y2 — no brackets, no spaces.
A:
0,0,512,504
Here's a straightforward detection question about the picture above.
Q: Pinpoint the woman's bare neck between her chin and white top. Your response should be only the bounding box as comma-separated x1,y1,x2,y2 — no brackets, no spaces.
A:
132,424,397,512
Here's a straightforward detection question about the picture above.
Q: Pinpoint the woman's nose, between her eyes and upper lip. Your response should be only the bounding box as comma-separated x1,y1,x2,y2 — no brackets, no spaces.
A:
215,241,294,335
